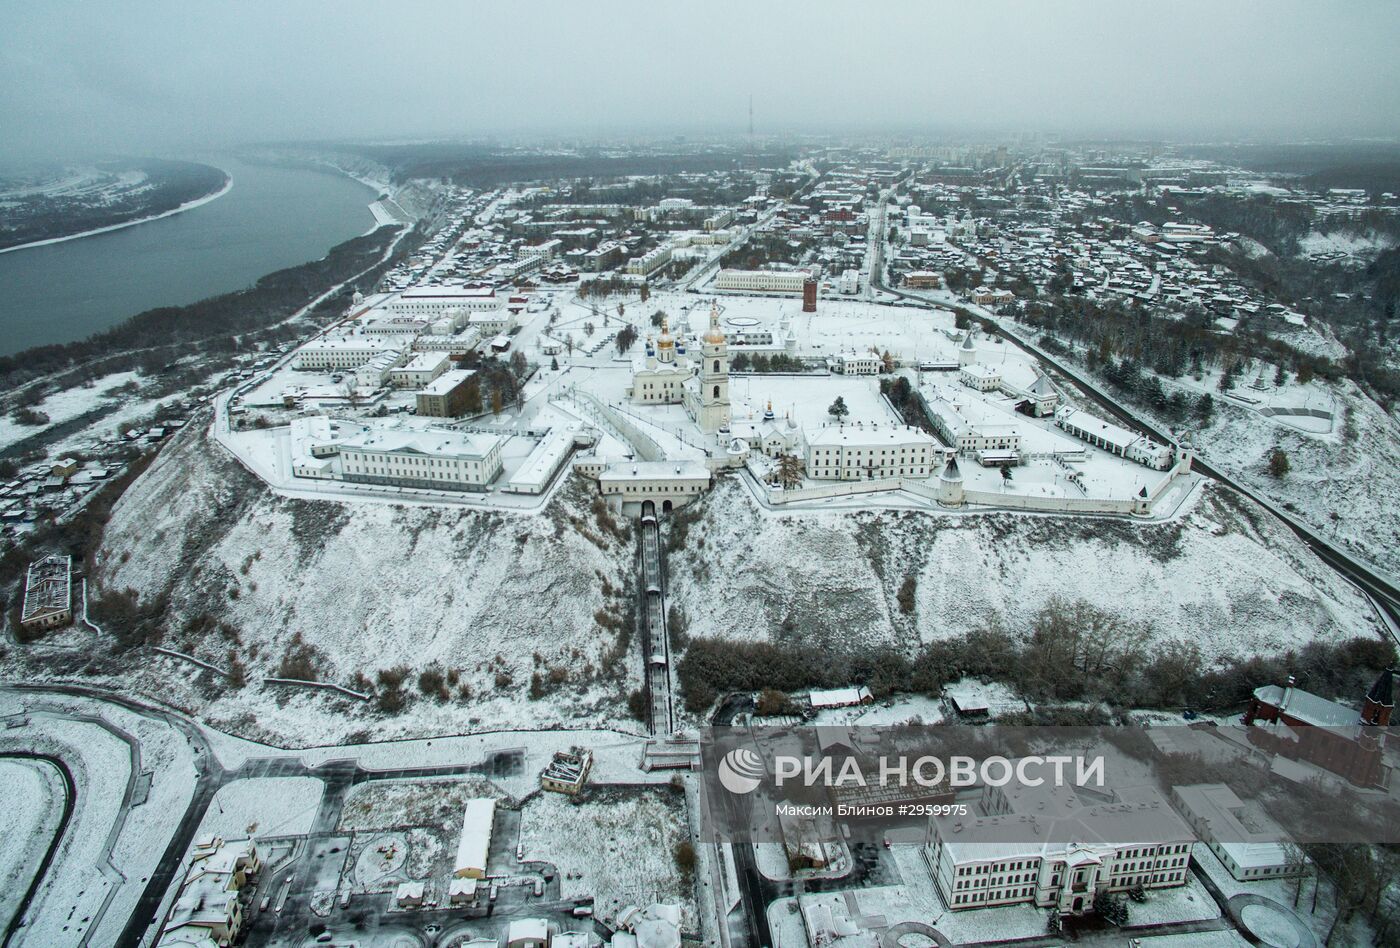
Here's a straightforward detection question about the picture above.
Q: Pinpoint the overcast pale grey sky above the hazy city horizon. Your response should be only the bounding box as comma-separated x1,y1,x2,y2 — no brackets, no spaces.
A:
0,0,1400,158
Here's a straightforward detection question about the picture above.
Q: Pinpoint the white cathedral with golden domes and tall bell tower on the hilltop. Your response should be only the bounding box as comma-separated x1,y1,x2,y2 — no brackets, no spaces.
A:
627,302,729,434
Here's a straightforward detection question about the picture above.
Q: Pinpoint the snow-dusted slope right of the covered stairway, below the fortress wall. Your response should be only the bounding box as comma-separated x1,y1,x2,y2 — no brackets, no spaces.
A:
669,482,1373,655
